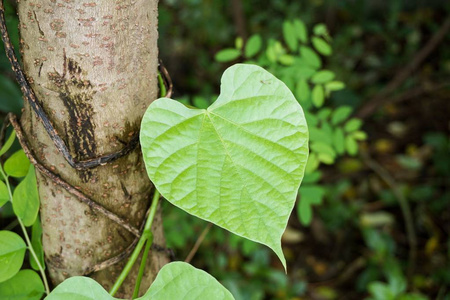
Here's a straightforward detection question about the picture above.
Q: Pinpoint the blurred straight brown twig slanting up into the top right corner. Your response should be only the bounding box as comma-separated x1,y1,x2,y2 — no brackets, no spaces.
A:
356,17,450,118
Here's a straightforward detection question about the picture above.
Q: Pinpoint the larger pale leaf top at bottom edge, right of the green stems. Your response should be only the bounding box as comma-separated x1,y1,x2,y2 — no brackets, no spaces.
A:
143,262,234,300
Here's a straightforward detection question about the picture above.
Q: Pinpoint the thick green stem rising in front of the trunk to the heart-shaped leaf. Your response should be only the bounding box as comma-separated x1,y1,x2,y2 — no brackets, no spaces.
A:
109,189,160,296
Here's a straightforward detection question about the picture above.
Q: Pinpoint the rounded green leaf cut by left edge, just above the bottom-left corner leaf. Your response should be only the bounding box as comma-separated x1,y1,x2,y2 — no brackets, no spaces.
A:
0,230,27,282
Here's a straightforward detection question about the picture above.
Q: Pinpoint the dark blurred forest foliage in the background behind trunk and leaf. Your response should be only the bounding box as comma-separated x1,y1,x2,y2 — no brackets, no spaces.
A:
0,0,450,300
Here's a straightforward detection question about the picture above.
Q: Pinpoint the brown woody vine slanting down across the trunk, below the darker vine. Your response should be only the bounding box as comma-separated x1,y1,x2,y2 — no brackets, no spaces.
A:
8,114,140,237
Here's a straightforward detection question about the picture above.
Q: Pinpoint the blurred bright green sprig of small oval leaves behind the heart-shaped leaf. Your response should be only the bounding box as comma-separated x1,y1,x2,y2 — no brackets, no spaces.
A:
214,19,367,225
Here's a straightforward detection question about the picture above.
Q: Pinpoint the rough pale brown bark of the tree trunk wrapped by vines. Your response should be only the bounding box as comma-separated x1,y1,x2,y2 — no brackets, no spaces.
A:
18,0,168,296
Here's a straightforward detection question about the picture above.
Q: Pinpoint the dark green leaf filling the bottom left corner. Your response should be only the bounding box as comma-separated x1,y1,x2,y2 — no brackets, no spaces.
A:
0,270,45,300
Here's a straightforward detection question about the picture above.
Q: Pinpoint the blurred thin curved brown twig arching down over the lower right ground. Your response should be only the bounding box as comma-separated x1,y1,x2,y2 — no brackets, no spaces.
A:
361,152,417,279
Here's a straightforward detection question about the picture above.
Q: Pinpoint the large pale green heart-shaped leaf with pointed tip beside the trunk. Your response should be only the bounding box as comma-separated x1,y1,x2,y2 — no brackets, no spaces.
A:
141,64,308,265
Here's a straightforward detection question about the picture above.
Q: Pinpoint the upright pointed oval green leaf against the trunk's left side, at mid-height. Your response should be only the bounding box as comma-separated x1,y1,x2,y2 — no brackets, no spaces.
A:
13,165,39,226
